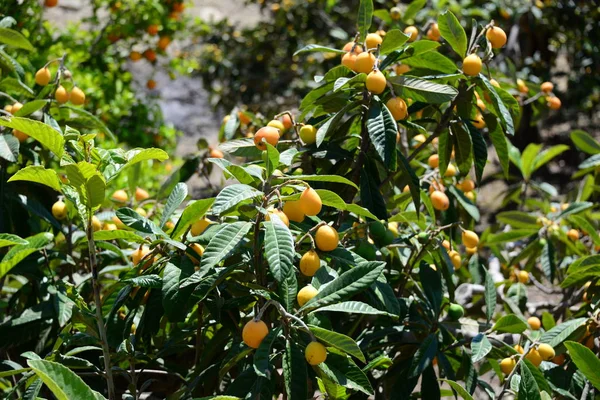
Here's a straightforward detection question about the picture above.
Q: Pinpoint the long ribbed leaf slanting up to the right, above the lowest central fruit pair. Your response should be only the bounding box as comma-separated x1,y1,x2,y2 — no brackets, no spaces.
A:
301,261,385,311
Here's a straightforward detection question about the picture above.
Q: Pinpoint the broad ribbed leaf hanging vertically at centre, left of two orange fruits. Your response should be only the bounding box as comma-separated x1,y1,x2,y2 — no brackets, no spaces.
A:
264,215,295,283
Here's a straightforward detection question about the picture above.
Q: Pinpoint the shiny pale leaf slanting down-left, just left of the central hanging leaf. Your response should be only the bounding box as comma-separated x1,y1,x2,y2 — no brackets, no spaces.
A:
200,222,252,274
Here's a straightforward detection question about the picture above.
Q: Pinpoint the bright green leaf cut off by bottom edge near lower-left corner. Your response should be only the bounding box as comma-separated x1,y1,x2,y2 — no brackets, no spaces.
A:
27,360,98,400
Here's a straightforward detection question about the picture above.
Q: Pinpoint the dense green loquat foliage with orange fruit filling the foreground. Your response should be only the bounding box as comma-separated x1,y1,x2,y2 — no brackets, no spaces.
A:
0,0,600,400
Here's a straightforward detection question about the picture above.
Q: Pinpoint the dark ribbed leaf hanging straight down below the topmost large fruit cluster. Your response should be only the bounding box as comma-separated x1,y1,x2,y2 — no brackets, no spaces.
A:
367,101,398,171
